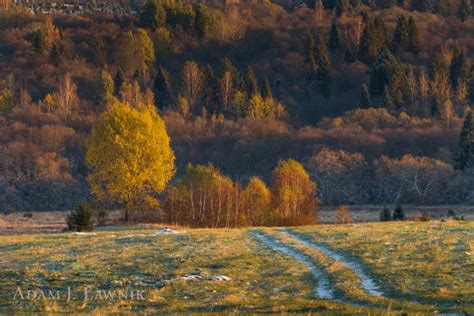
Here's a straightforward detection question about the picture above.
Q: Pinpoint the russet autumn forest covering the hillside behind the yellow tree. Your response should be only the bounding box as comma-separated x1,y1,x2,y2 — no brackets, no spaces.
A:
0,0,474,217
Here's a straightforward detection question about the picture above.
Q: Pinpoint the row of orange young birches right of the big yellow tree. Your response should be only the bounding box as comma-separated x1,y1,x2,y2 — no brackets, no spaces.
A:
165,160,319,227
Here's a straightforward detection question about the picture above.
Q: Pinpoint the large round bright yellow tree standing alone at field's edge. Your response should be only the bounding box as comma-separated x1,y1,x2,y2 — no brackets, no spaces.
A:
86,102,175,221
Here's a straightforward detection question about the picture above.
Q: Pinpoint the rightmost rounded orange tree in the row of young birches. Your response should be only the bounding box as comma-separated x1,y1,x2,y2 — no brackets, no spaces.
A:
272,159,319,226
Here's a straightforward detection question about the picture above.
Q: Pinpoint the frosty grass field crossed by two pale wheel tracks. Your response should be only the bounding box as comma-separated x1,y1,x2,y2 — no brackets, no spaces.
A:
0,221,474,315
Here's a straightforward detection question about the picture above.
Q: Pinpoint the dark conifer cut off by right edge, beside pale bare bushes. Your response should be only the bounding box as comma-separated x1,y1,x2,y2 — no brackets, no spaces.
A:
456,111,474,170
